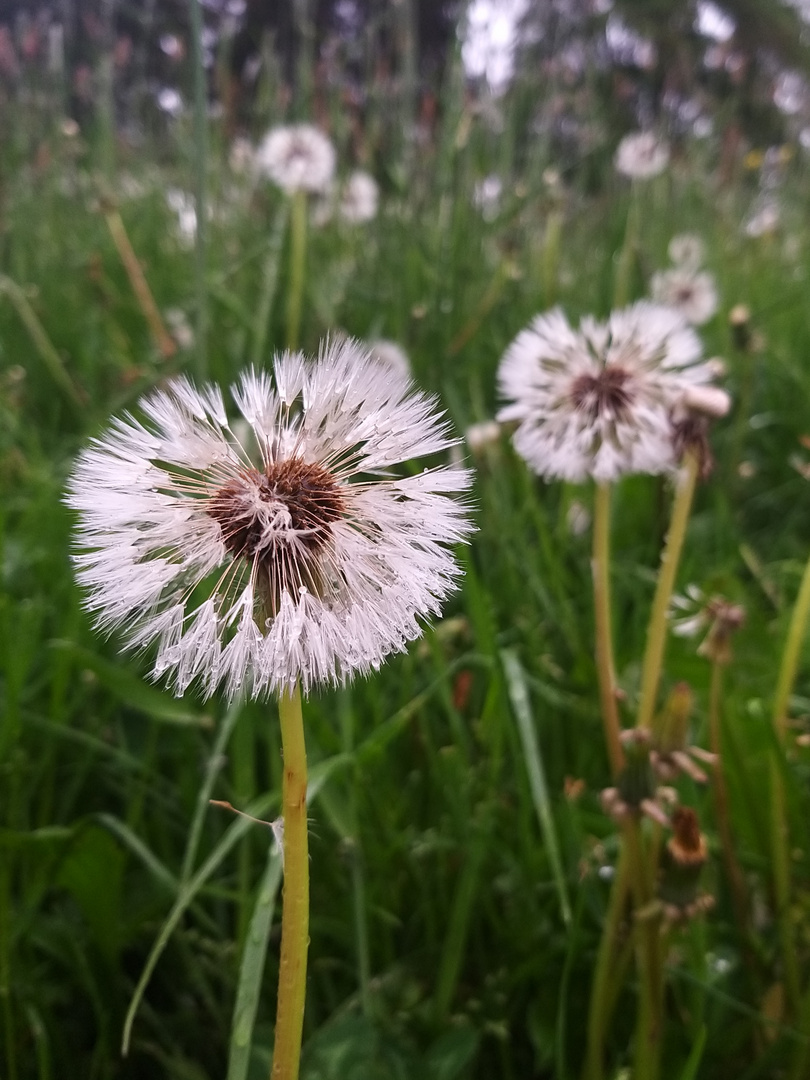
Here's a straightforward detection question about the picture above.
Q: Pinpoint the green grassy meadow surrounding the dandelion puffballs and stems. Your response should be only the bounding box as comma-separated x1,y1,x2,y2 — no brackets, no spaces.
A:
0,23,810,1080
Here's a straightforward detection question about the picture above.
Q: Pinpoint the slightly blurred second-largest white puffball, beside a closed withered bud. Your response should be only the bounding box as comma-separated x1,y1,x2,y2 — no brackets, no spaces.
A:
498,300,715,483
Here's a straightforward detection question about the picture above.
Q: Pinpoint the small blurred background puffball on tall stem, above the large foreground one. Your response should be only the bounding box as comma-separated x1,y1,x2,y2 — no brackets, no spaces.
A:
255,124,336,194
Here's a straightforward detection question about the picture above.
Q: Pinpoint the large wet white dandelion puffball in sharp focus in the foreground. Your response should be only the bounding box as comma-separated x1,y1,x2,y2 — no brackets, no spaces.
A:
66,341,472,698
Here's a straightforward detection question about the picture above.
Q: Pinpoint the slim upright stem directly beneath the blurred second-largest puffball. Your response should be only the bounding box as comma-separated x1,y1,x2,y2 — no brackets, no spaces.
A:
591,484,624,779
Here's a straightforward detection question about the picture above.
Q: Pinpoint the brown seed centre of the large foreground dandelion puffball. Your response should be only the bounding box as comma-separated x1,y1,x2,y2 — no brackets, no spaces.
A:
206,458,346,562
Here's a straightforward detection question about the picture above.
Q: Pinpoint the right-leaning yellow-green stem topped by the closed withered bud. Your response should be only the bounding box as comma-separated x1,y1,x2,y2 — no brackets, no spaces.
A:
637,450,699,728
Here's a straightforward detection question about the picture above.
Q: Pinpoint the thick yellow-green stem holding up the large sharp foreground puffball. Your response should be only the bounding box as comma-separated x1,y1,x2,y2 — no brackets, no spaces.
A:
271,685,309,1080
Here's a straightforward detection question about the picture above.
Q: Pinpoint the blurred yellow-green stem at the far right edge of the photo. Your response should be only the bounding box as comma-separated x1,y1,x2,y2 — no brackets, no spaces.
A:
771,558,810,1016
